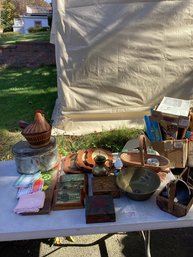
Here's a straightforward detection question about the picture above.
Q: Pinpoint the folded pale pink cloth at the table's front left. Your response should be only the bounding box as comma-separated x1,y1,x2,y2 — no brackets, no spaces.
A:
14,191,45,214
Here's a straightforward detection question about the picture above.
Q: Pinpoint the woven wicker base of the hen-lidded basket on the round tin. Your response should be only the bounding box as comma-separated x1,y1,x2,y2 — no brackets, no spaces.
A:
22,126,52,148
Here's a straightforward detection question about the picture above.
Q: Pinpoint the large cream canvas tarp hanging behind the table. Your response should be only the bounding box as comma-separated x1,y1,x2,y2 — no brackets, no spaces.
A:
51,0,193,135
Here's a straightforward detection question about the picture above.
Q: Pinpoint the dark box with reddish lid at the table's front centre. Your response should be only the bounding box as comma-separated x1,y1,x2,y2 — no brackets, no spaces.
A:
85,194,116,223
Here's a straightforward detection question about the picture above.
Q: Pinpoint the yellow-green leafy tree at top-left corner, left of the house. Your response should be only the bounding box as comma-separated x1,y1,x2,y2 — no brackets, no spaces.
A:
1,0,16,32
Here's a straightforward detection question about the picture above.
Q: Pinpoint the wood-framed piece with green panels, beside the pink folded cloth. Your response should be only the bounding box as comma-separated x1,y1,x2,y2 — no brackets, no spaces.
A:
53,174,88,210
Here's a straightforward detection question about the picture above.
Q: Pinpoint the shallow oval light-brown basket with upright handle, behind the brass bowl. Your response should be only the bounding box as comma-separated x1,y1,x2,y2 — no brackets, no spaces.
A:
120,135,170,172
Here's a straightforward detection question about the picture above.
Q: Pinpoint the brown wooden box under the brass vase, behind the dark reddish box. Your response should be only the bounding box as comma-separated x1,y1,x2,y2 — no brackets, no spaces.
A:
92,176,120,198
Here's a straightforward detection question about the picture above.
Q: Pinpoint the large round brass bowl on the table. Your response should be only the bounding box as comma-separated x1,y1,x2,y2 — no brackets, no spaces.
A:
116,166,161,201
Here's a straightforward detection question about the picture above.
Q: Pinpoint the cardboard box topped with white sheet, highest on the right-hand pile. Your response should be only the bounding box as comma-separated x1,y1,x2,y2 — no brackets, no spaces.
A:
151,97,190,128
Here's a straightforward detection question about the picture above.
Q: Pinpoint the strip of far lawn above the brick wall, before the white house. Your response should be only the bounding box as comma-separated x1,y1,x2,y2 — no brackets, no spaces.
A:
0,31,50,45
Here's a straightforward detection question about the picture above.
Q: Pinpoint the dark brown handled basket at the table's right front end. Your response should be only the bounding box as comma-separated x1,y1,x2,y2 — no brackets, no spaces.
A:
156,167,193,217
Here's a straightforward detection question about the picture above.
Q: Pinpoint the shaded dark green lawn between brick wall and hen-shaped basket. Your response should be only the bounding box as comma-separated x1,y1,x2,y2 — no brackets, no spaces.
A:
0,66,57,132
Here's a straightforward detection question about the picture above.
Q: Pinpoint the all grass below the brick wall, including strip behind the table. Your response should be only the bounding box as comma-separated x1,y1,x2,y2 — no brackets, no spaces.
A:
0,66,141,160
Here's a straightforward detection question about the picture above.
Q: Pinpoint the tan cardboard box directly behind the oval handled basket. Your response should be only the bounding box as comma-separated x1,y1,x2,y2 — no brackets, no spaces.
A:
150,139,188,168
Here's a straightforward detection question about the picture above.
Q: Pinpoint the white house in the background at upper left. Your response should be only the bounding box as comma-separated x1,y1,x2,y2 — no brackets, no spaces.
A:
13,6,52,34
